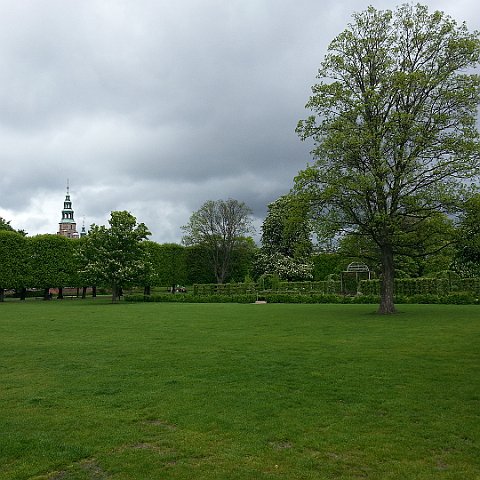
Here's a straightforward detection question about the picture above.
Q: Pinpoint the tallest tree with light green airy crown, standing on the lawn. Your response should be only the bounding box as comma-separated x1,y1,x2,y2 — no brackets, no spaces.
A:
296,5,480,314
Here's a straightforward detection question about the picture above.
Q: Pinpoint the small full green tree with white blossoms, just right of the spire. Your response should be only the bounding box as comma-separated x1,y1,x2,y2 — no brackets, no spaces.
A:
78,211,150,302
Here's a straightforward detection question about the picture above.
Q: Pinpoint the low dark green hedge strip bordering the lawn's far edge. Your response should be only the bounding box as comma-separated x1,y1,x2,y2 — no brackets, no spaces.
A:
124,292,480,305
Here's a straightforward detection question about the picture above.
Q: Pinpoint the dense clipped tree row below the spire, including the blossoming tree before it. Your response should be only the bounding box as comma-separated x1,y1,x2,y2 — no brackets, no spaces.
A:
0,211,255,301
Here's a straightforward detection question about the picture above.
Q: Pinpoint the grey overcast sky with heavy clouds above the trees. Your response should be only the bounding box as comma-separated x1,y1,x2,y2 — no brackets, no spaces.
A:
0,0,480,243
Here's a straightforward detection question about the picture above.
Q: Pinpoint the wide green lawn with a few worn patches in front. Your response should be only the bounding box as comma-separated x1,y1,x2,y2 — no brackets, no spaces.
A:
0,299,480,480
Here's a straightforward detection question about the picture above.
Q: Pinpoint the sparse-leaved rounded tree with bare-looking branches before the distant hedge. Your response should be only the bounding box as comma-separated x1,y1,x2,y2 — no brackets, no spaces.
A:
182,199,253,283
